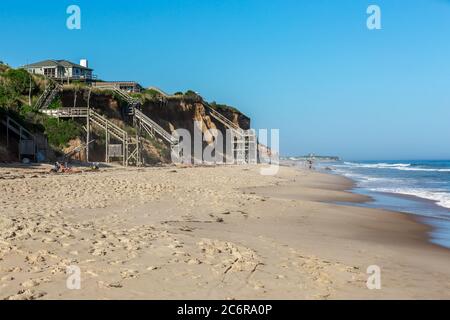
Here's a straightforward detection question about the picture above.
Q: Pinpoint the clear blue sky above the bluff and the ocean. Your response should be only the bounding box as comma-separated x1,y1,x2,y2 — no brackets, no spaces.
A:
0,0,450,160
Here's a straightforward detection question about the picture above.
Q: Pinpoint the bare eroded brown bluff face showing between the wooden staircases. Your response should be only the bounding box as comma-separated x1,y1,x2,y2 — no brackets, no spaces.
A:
61,87,250,163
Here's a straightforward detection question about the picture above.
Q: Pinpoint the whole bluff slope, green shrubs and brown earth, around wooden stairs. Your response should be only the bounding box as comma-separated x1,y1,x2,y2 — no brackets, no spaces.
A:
0,64,249,163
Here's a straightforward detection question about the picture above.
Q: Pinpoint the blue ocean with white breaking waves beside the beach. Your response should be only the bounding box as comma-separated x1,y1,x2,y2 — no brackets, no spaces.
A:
316,160,450,248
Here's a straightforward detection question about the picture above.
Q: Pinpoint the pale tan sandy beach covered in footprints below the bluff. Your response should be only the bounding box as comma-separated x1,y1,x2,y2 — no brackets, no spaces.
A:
0,166,450,299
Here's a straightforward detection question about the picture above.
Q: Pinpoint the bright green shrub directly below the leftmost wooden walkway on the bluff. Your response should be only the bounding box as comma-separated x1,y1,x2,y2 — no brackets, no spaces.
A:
44,118,82,147
